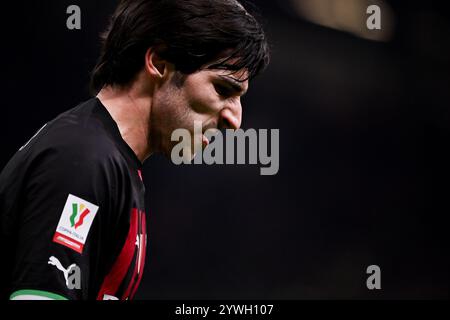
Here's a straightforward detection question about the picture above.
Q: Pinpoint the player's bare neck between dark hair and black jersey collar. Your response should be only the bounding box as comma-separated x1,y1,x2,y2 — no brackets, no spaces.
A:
97,81,152,162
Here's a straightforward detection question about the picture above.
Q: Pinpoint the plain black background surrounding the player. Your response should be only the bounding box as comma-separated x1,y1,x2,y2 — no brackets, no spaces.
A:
0,0,450,299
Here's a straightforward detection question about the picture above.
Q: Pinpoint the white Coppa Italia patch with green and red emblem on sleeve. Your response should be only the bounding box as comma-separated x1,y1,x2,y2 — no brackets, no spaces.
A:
53,194,98,253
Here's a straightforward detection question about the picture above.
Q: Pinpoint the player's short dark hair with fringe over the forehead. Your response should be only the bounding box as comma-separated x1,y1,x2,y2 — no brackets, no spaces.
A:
91,0,269,92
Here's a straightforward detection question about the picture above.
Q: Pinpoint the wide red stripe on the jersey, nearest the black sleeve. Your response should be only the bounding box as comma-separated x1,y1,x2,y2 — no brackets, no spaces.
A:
97,209,138,300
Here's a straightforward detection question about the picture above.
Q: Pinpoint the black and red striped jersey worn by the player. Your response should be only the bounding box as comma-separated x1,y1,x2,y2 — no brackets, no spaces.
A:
0,98,147,300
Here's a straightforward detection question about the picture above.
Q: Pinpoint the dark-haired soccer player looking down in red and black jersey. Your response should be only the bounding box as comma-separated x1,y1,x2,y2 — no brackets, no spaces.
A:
0,0,269,300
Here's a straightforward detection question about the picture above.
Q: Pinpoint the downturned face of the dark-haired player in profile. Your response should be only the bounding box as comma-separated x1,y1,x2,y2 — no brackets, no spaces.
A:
150,70,248,156
